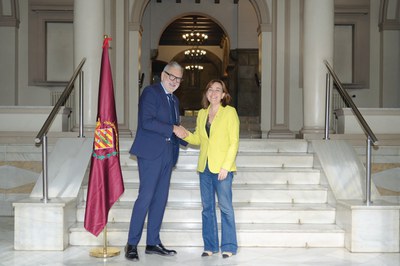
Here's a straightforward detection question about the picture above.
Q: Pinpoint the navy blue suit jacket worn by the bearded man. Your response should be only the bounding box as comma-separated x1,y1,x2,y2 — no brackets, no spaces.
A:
130,83,179,166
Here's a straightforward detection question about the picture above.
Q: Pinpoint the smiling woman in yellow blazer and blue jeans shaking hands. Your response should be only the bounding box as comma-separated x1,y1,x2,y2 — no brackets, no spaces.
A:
184,79,239,258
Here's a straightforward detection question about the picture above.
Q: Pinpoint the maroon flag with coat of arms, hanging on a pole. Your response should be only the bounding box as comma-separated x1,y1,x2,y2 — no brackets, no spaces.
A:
84,38,124,236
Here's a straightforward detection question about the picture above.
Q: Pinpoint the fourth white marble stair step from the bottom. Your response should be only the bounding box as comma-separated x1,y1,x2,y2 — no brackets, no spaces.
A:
122,166,320,184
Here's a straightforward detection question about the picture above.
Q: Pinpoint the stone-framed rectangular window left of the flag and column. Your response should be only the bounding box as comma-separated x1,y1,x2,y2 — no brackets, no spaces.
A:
28,0,73,86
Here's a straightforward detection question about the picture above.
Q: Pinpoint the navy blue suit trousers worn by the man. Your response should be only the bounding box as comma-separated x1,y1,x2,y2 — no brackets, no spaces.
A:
128,142,173,245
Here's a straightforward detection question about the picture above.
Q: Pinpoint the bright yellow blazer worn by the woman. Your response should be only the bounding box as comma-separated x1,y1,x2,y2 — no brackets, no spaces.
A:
184,105,240,174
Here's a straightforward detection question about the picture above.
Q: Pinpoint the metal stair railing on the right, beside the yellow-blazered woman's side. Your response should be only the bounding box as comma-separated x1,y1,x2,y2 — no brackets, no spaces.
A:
324,60,378,206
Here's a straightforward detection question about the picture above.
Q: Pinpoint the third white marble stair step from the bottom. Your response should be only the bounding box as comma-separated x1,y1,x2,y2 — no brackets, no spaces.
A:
83,183,327,203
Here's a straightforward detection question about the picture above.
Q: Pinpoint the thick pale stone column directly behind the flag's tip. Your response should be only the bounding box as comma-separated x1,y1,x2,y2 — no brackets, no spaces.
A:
74,0,104,130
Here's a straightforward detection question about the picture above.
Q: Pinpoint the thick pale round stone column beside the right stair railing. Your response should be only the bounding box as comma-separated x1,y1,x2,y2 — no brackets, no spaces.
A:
301,0,334,134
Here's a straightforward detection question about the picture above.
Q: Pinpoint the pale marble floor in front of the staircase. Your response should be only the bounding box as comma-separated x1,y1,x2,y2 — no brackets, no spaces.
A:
0,217,400,266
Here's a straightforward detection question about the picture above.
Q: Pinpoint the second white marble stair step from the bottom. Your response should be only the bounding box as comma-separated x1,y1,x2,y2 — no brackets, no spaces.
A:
77,202,335,224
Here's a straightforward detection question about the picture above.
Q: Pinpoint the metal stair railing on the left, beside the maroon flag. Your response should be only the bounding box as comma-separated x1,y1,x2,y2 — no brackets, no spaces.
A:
35,58,86,203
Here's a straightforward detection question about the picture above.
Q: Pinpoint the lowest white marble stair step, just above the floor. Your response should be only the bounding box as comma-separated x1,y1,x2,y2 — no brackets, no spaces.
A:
70,222,344,247
